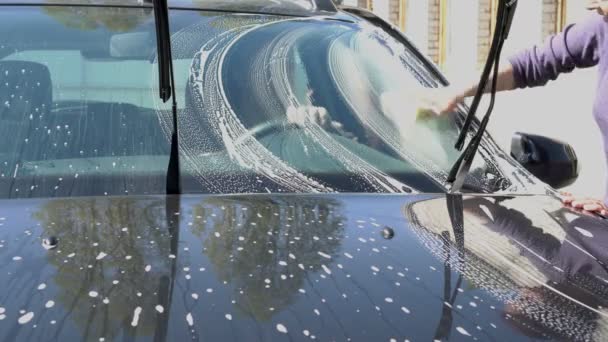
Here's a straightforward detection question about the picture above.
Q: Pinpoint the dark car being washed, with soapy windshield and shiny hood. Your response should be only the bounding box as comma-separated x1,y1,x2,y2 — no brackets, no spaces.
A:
0,0,608,341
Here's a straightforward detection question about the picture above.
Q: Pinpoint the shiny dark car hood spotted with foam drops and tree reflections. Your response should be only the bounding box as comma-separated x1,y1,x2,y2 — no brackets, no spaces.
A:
0,195,608,341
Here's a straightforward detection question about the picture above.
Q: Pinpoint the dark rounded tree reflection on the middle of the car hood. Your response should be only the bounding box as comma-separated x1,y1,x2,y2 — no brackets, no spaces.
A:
194,198,344,321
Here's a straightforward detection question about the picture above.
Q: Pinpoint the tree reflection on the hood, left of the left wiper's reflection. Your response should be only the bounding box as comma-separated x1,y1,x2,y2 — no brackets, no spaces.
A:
34,199,170,341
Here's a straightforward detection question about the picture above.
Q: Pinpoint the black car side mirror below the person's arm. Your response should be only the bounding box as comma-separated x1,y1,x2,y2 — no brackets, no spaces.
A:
511,132,580,189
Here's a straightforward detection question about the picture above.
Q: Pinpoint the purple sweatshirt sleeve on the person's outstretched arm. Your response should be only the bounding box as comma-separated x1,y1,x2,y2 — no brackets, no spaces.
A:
509,15,606,88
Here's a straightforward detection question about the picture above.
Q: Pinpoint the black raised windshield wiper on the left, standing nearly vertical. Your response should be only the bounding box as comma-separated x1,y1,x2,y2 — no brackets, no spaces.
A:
148,0,181,195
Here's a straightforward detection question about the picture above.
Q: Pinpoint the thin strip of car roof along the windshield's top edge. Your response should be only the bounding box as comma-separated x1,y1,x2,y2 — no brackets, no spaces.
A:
0,0,337,16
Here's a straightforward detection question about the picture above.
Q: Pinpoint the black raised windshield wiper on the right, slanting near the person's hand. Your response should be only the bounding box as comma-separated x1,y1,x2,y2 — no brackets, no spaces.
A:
447,0,517,193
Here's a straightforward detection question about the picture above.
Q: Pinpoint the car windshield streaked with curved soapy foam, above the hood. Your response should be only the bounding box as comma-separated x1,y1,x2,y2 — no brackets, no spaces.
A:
0,6,534,198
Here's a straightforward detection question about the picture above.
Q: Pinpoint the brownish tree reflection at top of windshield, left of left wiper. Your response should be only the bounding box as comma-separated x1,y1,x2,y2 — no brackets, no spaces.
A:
43,0,152,32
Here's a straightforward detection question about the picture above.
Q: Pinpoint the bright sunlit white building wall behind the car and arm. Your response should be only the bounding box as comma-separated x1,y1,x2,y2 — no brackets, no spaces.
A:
336,0,606,198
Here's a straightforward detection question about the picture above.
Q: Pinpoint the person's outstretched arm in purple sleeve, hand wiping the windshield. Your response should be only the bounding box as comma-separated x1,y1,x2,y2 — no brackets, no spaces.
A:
427,15,608,114
